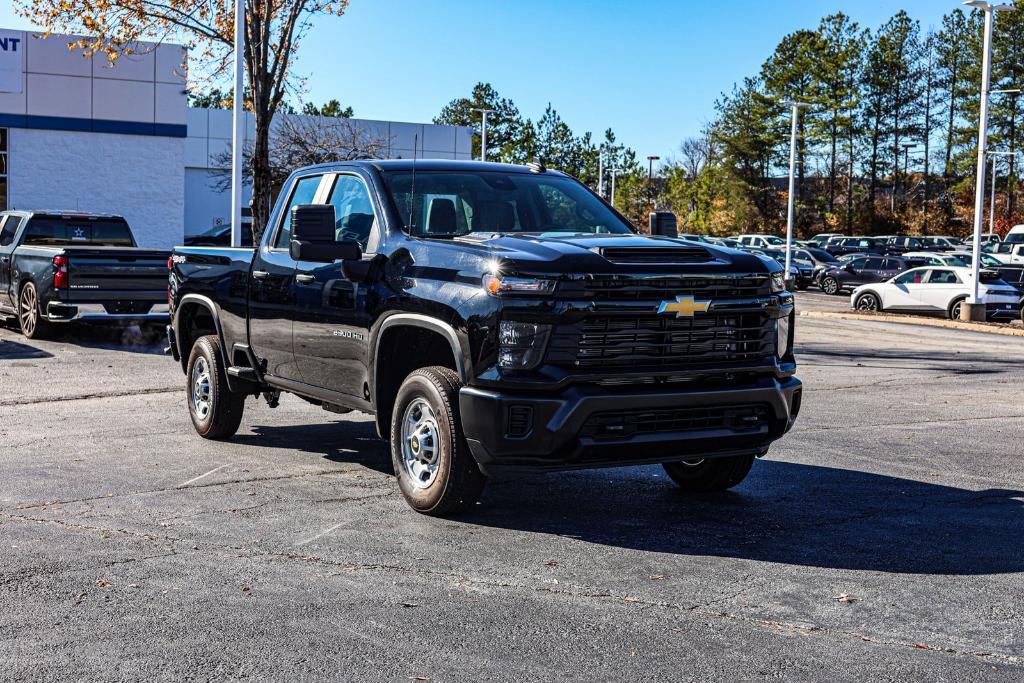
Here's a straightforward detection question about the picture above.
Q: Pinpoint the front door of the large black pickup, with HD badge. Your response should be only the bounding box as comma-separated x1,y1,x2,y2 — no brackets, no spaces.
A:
293,173,379,398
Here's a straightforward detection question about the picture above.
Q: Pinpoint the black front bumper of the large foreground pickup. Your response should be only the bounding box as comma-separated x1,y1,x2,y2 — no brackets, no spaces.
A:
459,377,801,476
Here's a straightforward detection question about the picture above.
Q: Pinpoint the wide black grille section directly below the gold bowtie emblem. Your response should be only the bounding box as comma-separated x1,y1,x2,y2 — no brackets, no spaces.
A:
548,312,774,371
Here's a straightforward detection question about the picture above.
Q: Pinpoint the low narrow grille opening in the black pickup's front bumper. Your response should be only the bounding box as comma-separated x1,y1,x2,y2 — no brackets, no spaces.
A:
581,403,769,439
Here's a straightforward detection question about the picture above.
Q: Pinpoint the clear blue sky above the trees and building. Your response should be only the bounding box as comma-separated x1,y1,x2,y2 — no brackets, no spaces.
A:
0,0,958,162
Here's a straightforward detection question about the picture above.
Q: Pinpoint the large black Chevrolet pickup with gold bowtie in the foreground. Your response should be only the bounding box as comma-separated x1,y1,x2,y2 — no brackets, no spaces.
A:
168,160,801,515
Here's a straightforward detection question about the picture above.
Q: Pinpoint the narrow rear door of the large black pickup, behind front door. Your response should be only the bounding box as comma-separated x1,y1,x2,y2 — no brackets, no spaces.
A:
249,173,324,382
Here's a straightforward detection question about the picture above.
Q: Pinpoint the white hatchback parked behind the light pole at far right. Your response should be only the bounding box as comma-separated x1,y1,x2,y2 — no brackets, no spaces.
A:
850,266,1024,321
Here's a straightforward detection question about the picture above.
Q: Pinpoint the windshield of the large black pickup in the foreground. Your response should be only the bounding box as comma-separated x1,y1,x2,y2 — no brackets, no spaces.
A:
383,171,633,237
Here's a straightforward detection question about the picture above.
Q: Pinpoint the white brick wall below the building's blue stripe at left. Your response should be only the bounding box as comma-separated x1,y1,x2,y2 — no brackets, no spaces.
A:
8,128,185,248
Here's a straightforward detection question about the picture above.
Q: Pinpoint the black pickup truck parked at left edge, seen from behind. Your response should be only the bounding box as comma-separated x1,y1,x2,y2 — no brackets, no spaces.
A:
0,211,171,339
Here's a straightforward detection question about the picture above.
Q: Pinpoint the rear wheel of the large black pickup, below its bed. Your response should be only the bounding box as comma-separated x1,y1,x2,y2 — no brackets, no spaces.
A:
185,335,246,439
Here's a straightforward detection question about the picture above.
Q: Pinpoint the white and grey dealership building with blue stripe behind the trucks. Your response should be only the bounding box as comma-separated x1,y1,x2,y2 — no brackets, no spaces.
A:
0,30,471,247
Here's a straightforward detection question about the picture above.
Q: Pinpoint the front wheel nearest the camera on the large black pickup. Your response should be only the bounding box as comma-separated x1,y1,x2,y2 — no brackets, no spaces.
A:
391,366,486,517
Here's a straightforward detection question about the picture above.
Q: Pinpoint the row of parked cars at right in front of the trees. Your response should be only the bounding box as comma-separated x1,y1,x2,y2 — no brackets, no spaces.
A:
684,225,1024,321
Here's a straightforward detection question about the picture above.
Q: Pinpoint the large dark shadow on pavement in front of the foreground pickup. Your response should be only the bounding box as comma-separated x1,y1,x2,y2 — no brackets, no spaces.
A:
462,461,1024,574
